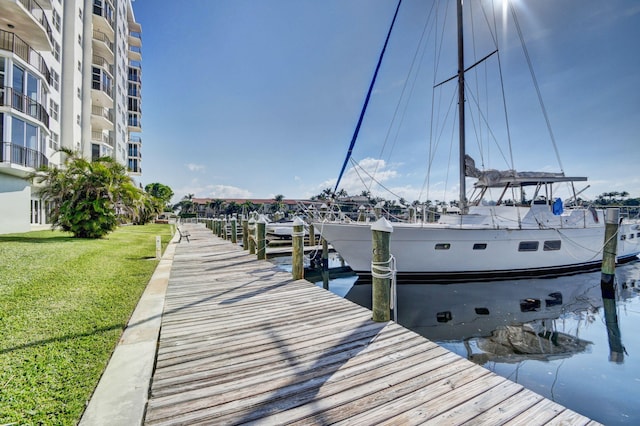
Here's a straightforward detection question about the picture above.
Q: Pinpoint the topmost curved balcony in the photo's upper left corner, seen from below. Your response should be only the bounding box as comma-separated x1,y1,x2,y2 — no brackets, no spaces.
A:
0,0,53,51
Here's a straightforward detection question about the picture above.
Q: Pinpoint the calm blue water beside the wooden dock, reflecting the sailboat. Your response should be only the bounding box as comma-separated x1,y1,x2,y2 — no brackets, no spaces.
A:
272,255,640,425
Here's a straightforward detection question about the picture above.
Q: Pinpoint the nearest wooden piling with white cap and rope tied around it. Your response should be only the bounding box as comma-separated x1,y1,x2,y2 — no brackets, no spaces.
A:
371,217,393,322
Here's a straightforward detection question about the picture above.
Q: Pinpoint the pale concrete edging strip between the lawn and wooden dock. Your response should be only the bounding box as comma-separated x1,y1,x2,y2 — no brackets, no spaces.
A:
78,232,179,426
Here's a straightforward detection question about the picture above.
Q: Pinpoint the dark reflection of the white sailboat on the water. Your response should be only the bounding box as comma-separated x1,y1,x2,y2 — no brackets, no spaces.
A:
345,262,640,365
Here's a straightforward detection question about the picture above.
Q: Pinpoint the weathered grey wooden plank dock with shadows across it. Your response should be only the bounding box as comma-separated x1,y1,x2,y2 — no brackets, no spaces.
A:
145,225,597,425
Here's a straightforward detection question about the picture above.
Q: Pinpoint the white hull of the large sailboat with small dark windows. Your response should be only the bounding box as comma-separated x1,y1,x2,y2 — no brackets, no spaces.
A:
315,216,640,281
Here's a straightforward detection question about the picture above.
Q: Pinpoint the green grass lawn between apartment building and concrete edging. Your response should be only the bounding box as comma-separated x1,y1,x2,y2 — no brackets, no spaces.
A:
0,225,171,425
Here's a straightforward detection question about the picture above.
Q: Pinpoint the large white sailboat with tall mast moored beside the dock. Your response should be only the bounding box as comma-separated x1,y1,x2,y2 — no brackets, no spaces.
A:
314,0,640,282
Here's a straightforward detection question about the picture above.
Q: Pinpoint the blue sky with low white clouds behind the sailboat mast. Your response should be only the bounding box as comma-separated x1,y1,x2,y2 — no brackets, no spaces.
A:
134,0,640,201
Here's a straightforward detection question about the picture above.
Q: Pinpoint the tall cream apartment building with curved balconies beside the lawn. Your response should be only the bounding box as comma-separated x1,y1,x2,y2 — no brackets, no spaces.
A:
0,0,142,234
